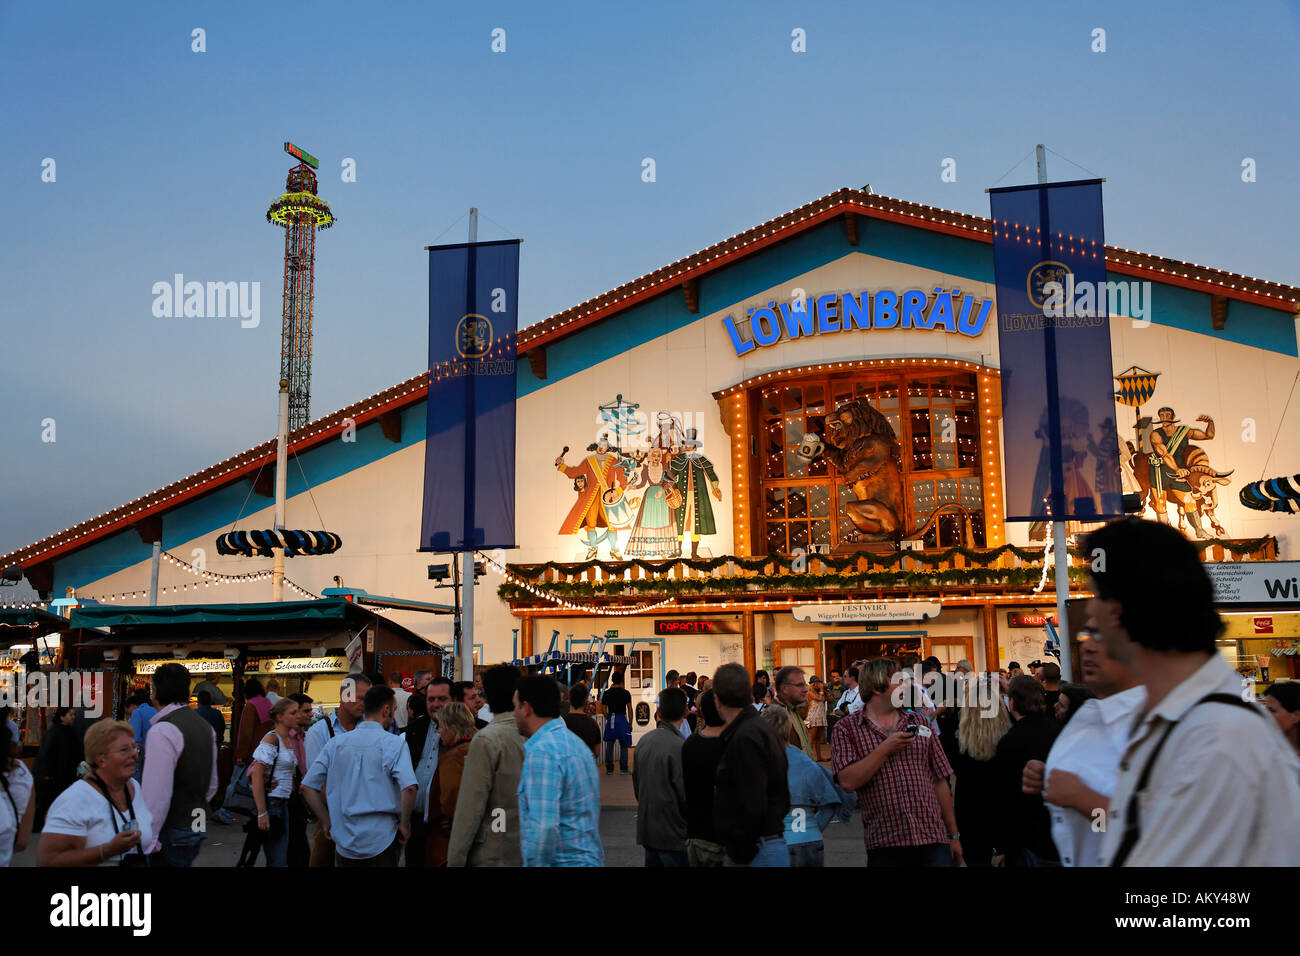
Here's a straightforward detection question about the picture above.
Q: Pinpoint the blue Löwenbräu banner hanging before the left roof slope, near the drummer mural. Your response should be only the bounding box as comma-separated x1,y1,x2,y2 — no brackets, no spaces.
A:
420,239,521,551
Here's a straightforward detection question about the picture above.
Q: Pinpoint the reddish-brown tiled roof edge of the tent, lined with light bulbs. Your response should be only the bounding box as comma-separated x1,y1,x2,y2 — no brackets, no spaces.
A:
0,189,1300,567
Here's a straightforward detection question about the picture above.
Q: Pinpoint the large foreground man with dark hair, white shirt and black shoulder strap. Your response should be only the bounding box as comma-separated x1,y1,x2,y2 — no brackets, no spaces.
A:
1083,519,1300,866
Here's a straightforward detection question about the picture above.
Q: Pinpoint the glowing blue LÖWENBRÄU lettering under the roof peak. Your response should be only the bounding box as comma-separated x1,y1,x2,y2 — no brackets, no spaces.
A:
723,287,993,355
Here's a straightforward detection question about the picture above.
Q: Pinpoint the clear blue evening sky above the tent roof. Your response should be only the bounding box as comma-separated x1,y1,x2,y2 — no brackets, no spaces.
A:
0,0,1300,553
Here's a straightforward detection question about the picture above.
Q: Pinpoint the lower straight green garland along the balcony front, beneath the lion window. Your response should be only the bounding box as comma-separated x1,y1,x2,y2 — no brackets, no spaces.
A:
497,567,1088,602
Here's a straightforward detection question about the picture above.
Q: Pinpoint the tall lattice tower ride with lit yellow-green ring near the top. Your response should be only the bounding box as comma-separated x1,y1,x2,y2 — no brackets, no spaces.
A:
267,143,335,432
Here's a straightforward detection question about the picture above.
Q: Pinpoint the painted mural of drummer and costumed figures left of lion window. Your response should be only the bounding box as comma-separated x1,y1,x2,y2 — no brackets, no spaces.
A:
555,394,723,561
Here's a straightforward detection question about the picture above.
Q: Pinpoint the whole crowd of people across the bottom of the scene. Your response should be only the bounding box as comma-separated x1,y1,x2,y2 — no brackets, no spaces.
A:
0,520,1300,868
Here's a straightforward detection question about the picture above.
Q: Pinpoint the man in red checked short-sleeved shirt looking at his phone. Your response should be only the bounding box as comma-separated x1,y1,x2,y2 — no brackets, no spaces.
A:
831,658,962,866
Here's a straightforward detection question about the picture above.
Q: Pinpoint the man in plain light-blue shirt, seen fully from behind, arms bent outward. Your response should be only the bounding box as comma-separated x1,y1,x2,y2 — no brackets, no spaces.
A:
302,687,416,866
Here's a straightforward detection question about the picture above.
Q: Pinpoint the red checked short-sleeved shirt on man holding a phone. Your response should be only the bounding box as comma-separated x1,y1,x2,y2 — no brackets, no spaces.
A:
831,710,953,852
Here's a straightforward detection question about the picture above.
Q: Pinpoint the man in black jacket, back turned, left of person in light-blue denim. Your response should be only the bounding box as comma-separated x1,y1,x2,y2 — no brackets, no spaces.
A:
714,663,790,866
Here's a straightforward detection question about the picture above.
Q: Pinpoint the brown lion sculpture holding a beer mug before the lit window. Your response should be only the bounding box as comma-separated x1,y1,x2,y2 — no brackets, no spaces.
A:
801,398,904,541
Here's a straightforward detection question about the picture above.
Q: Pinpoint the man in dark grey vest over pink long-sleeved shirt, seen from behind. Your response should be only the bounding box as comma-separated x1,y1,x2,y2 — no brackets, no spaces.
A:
140,662,217,866
